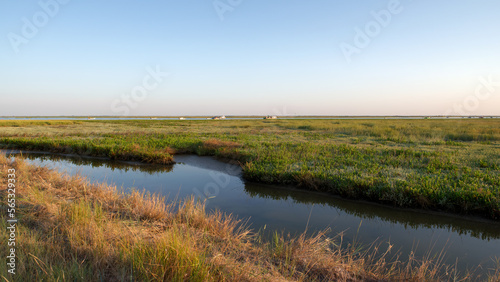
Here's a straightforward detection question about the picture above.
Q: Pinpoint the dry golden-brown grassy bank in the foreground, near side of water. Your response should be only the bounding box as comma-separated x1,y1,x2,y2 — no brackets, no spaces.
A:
0,156,494,281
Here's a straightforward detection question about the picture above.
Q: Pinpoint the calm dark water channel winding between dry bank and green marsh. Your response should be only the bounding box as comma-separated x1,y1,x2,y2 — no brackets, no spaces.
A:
3,151,500,276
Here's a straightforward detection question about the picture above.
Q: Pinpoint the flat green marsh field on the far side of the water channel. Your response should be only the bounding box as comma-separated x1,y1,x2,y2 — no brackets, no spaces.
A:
0,119,500,219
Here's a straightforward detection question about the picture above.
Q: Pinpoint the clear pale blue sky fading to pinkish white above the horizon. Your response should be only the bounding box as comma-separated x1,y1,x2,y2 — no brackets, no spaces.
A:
0,0,500,116
